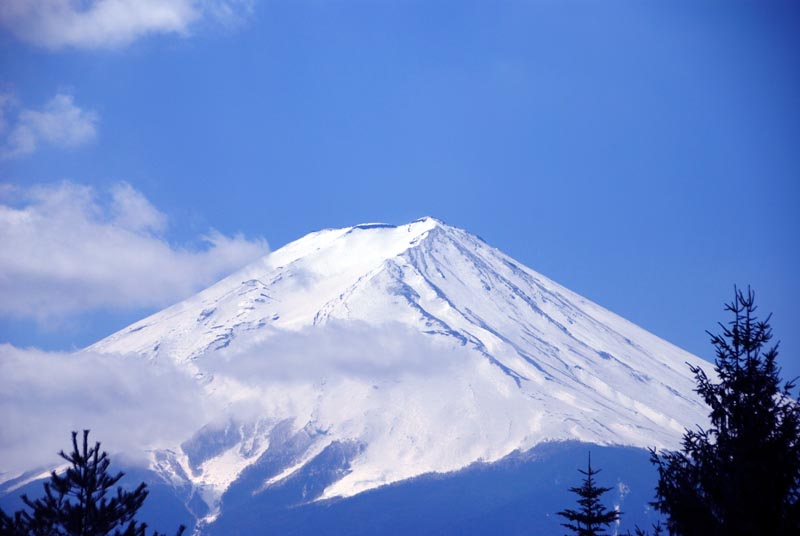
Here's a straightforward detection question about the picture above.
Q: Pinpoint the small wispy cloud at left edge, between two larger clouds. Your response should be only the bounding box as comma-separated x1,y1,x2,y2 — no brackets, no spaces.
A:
0,93,98,158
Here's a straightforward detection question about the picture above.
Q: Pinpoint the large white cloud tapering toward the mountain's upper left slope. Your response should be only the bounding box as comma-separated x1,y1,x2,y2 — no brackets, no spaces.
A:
0,182,267,323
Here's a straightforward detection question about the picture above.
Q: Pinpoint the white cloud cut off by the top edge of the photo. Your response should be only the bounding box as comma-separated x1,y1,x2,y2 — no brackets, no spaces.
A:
0,0,254,49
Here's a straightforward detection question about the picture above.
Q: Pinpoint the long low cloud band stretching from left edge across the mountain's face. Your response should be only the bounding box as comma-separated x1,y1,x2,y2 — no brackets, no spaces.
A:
0,323,475,482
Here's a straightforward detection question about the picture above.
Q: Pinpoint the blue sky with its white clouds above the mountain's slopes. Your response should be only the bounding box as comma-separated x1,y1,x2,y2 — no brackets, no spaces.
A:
0,0,800,382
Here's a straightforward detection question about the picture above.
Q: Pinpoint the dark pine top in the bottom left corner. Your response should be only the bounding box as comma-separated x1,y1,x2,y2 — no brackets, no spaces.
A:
0,430,185,536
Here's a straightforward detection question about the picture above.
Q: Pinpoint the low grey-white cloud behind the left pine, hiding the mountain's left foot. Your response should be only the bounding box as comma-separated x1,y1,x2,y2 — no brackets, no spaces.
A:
0,344,214,476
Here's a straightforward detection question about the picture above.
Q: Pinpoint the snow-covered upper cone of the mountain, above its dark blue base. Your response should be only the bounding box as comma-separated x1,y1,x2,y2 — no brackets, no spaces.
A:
86,218,707,522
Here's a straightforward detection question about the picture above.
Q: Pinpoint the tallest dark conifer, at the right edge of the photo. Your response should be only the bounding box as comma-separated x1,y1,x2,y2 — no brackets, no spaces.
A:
651,288,800,536
